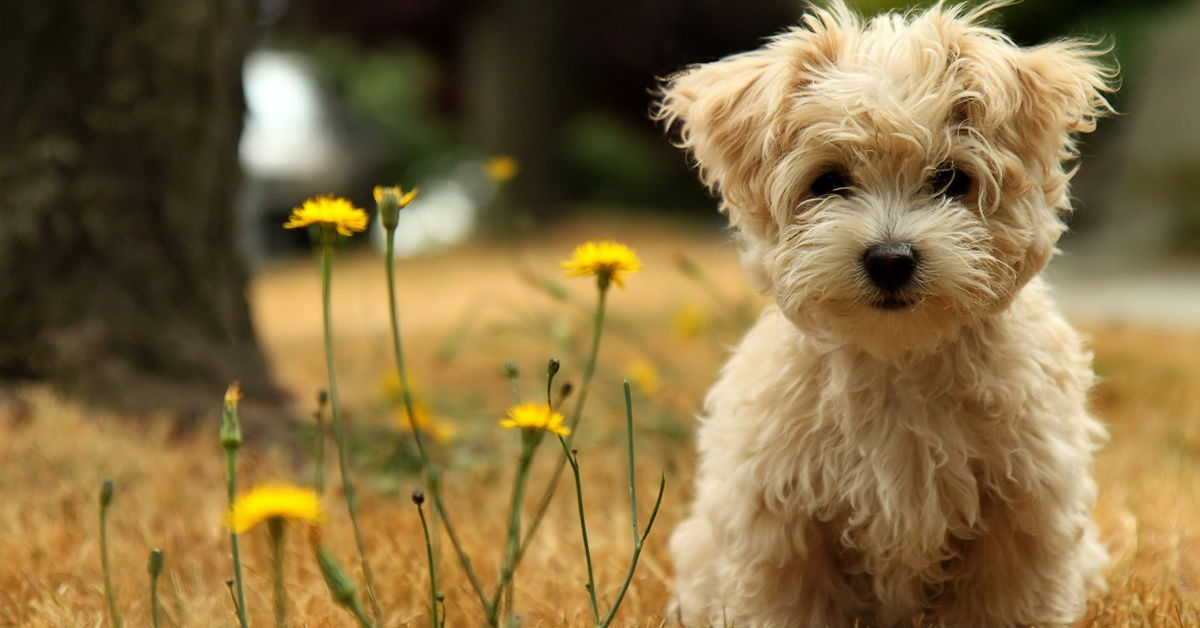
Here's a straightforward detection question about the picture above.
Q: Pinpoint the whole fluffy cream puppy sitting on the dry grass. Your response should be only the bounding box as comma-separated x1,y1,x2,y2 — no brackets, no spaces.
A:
658,0,1114,627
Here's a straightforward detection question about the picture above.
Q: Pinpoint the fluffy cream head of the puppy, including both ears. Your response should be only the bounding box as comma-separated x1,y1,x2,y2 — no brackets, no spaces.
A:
656,0,1115,357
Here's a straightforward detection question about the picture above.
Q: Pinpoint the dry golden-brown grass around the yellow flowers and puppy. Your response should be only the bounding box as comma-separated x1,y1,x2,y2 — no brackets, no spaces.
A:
0,213,1200,626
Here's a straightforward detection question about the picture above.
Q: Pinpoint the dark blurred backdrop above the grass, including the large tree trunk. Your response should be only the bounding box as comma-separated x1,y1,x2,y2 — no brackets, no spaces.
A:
0,0,1200,422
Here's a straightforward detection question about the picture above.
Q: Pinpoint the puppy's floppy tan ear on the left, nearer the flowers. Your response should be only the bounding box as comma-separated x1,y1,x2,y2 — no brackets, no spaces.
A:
653,6,857,227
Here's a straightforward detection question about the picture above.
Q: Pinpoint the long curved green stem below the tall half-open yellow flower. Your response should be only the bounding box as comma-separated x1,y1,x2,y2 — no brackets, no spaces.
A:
384,228,488,612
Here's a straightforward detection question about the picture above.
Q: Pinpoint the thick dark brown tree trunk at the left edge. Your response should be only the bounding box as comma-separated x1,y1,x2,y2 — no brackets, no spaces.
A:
0,0,281,417
